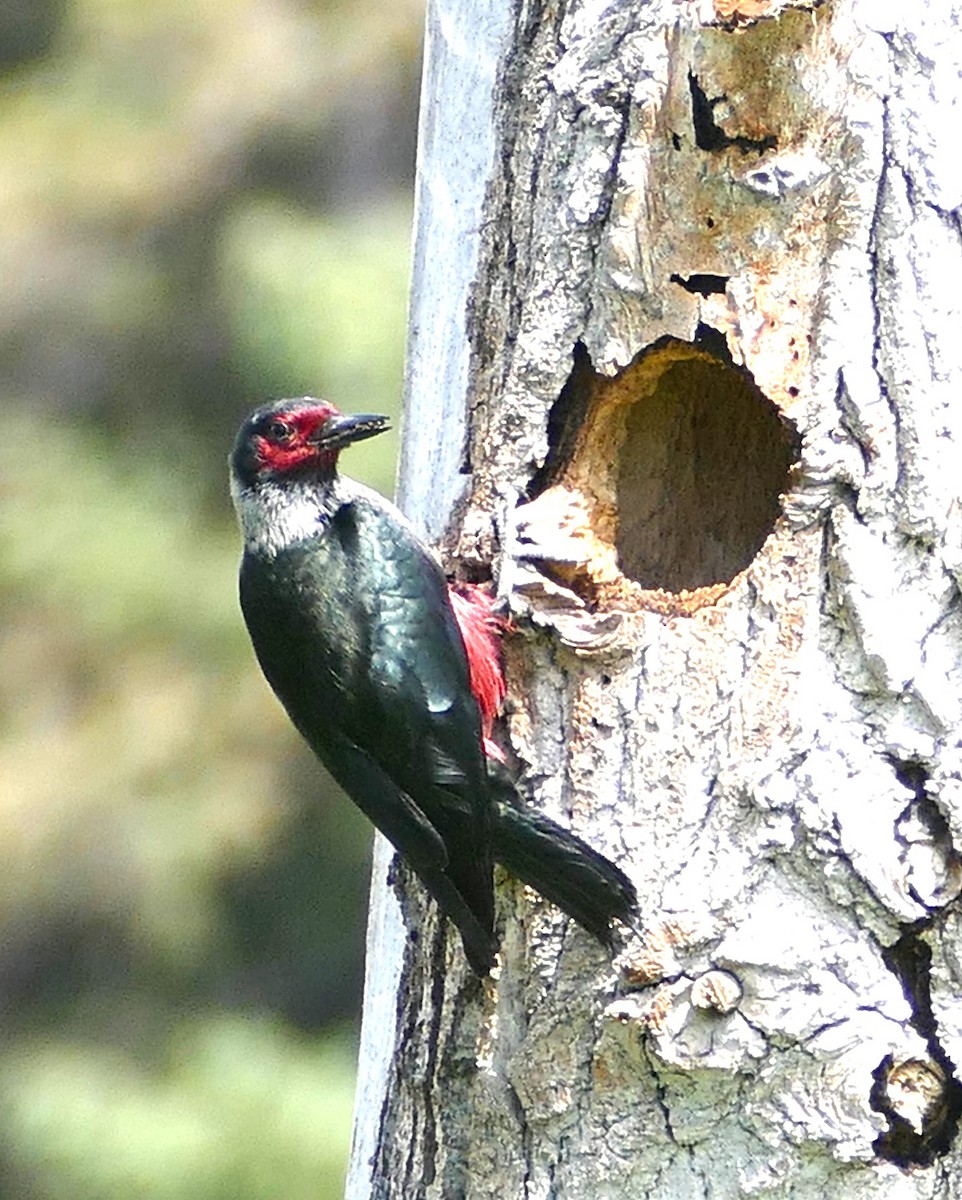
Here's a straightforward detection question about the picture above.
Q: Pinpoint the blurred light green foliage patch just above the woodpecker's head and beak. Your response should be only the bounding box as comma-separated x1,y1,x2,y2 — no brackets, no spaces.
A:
221,200,410,494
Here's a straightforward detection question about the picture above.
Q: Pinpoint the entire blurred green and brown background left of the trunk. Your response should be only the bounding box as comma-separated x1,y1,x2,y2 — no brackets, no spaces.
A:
0,0,421,1200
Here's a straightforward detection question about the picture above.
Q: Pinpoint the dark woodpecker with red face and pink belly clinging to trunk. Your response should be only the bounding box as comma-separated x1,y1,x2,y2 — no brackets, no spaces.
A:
230,397,636,974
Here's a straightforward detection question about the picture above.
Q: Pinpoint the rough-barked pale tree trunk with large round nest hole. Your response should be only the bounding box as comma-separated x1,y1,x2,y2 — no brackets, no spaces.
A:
348,0,962,1200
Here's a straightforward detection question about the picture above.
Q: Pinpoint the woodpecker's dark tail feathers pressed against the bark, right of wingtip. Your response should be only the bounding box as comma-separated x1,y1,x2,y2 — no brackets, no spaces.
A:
493,798,638,948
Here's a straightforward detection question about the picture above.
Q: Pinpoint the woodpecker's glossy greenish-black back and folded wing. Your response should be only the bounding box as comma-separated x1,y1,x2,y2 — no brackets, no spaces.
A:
241,487,493,967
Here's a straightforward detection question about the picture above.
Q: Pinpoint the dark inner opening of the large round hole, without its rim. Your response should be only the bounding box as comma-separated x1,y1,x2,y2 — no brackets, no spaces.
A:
615,347,799,592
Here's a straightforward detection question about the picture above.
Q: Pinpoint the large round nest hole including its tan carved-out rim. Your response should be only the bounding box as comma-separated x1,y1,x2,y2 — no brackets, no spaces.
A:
529,340,800,613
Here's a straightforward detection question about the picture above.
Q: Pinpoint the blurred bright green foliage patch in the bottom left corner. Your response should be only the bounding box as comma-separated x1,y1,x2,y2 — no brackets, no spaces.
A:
0,1016,354,1200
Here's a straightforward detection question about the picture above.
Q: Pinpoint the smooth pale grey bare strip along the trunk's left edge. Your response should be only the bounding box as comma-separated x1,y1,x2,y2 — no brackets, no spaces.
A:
345,0,510,1200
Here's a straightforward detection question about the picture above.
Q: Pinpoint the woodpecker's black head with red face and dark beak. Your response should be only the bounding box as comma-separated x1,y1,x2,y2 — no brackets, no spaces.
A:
230,396,389,490
